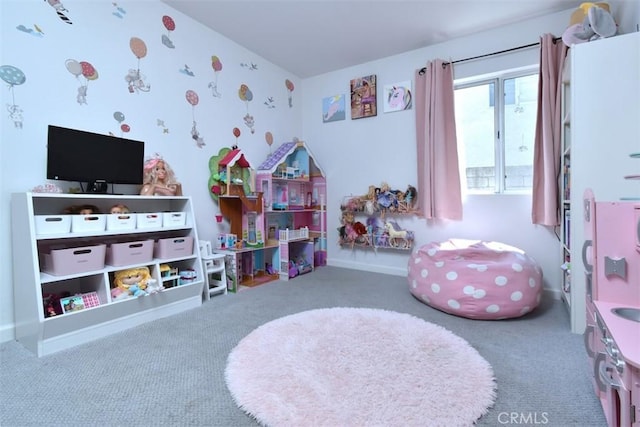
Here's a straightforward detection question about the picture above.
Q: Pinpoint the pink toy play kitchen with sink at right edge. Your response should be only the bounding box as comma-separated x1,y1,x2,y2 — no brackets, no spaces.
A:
582,190,640,427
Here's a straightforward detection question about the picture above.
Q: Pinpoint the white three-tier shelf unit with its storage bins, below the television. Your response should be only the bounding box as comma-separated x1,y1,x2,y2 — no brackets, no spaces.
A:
11,193,204,357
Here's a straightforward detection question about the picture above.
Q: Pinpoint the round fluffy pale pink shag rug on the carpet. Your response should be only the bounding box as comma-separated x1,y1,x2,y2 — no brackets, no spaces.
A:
225,307,496,427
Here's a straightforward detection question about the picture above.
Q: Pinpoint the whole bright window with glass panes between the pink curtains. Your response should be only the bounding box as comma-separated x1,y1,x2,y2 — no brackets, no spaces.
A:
455,70,538,193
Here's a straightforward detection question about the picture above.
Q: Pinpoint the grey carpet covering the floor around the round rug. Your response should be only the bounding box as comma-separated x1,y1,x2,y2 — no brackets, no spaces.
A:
0,267,606,427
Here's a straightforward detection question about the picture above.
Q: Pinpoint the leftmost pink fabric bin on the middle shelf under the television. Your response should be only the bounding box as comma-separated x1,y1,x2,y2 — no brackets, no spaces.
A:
41,244,106,276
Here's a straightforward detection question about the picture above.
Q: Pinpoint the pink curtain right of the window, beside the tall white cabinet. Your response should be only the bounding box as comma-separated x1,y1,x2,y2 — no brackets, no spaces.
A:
531,34,567,226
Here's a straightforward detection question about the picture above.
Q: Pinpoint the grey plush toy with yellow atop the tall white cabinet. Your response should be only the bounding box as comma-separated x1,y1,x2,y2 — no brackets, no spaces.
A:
562,3,618,46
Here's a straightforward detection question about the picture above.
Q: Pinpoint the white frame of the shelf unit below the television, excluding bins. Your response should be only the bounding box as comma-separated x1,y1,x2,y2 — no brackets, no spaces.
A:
11,193,204,357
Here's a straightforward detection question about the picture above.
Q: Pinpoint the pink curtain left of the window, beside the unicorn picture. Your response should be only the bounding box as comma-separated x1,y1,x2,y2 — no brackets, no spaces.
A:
415,59,462,220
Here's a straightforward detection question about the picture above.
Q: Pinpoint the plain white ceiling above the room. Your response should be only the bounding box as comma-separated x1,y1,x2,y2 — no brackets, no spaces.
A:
164,0,580,78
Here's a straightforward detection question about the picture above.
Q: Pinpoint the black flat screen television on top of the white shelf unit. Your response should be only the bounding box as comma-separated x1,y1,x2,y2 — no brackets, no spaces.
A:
47,125,144,193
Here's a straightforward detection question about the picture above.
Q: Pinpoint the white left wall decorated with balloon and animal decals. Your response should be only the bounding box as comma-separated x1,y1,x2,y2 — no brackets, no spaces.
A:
0,0,302,341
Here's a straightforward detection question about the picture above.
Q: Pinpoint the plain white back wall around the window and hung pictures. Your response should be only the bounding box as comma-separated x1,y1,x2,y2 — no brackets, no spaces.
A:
303,2,640,288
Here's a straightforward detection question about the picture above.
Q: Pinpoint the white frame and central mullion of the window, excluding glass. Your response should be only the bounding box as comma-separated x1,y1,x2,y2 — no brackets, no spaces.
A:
453,64,540,195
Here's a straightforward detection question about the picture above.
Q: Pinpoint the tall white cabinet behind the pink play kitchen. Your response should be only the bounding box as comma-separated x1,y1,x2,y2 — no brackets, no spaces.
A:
569,32,640,333
